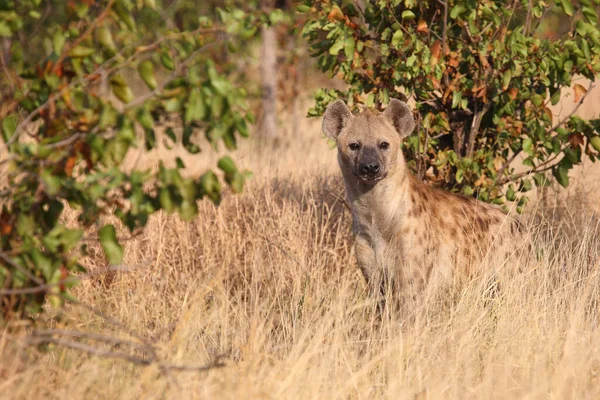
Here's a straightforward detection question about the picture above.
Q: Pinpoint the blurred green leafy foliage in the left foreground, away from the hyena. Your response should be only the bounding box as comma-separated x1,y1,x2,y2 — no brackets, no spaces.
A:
0,0,268,322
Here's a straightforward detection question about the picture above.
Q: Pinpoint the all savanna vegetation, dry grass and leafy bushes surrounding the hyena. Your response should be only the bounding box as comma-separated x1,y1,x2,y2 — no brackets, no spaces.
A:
0,0,600,398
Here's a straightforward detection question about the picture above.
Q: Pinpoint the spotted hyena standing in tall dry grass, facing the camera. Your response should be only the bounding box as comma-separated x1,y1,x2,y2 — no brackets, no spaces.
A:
323,100,517,304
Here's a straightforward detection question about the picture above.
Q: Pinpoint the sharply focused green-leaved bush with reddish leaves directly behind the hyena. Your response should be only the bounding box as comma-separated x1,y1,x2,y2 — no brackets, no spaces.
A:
298,0,600,211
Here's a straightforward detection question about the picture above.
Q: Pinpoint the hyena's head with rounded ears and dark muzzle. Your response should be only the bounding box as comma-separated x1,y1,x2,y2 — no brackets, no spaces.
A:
323,99,415,185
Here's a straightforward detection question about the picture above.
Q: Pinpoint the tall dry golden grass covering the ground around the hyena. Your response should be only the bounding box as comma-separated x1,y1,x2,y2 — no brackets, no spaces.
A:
0,95,600,399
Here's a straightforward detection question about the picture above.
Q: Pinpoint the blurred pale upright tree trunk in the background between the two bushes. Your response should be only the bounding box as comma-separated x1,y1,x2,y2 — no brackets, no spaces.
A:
260,25,277,139
